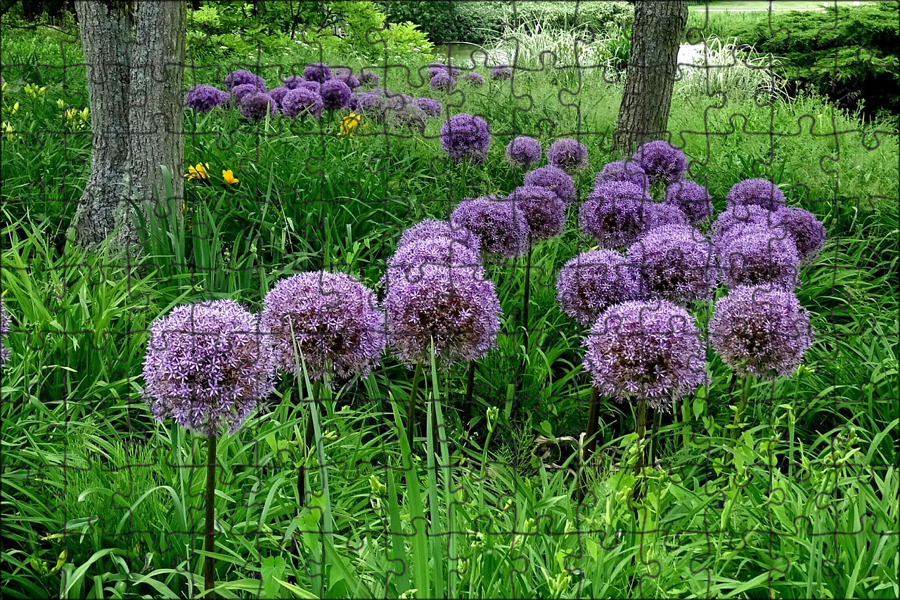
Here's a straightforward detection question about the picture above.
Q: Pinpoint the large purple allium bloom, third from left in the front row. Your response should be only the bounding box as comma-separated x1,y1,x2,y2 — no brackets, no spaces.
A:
385,265,501,367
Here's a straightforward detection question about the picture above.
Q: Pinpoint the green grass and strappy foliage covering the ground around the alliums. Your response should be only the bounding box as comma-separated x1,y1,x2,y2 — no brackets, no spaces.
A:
0,14,900,598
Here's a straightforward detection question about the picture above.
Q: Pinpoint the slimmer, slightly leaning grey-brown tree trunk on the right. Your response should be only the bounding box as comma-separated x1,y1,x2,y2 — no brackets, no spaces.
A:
613,0,688,153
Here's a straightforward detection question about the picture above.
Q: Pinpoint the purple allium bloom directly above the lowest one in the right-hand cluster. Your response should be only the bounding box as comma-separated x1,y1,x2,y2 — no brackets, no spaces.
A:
627,225,716,304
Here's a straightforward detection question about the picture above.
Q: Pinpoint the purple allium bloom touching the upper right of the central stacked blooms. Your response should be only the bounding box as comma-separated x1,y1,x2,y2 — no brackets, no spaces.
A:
450,197,530,258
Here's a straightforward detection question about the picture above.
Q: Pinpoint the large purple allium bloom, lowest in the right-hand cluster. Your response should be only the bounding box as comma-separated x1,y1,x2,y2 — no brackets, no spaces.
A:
584,300,706,412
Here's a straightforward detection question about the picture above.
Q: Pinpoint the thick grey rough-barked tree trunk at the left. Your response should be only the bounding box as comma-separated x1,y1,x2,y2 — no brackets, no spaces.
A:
75,0,187,248
